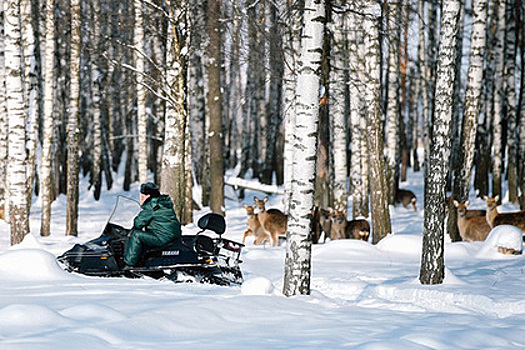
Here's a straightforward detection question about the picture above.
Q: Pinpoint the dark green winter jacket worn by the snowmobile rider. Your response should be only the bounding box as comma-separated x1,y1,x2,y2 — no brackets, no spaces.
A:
133,194,181,243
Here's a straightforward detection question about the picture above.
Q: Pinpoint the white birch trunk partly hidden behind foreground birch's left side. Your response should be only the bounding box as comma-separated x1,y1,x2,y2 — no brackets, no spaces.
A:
283,0,302,214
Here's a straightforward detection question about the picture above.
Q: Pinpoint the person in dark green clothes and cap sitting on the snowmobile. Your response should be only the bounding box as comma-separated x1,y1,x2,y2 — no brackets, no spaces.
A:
124,182,181,270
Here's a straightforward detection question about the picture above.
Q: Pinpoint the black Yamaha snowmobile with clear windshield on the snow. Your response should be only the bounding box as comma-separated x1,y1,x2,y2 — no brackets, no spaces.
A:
57,196,244,285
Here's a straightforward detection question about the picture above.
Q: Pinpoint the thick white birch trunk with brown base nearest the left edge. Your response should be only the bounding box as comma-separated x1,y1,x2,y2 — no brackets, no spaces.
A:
4,0,29,245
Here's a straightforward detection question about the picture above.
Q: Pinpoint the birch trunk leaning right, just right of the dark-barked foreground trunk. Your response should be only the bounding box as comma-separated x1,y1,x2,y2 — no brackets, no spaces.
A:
449,0,488,241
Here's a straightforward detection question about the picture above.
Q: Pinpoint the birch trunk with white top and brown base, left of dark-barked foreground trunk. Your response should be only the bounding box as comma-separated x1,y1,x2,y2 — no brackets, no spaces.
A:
361,0,392,244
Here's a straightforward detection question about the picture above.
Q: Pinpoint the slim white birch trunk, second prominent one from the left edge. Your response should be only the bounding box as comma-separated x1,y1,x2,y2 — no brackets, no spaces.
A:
40,0,55,236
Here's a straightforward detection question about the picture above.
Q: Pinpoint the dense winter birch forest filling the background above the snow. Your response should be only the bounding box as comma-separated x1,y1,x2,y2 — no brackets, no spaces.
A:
0,0,525,295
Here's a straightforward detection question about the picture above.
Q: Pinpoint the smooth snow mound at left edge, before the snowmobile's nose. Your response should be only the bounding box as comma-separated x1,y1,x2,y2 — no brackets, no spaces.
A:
0,249,75,281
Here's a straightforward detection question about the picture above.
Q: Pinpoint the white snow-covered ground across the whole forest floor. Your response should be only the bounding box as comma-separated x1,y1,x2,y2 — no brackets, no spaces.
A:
0,174,525,350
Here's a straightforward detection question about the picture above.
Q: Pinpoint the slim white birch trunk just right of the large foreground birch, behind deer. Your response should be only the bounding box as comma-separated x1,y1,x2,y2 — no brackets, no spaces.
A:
329,2,348,212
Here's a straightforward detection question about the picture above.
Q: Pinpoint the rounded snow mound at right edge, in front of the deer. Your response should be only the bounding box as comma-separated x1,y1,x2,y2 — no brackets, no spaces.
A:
478,225,523,258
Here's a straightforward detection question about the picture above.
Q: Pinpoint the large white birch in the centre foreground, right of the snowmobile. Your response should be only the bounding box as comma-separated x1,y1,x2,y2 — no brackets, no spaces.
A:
283,0,325,296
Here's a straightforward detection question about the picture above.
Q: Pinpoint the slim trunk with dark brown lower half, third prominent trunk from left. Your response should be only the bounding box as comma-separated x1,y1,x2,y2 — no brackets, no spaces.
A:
66,0,82,236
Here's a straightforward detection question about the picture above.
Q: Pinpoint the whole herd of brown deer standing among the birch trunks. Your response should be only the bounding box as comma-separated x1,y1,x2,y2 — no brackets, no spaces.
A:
242,190,525,246
